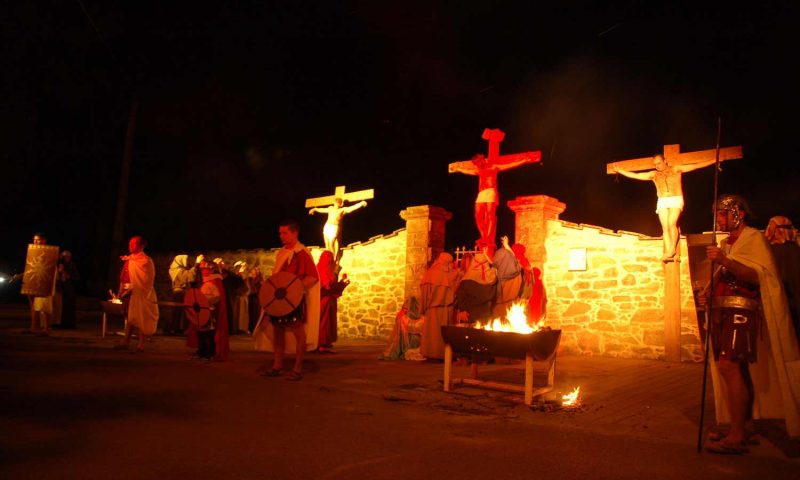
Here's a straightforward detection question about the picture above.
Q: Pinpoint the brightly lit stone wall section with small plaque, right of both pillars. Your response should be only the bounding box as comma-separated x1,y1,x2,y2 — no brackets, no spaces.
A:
543,219,702,361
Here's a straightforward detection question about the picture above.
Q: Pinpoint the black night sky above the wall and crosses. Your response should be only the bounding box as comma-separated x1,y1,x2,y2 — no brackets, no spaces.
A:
0,0,800,293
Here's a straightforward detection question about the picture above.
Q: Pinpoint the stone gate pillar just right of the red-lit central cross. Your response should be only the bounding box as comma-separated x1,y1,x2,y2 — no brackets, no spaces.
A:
508,195,567,273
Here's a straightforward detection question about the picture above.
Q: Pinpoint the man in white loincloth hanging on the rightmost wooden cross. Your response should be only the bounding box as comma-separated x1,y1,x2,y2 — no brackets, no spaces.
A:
613,153,715,262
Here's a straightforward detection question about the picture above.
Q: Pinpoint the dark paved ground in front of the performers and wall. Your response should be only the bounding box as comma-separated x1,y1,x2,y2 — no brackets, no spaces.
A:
0,306,800,480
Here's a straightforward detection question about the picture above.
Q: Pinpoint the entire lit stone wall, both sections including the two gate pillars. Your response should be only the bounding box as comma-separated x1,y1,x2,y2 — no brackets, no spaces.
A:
154,191,702,361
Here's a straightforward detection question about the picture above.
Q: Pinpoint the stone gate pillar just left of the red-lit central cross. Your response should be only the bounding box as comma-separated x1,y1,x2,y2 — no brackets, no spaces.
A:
400,205,453,298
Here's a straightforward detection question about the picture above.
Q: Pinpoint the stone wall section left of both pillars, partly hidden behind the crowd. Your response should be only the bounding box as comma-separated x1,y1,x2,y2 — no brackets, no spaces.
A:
153,229,407,340
